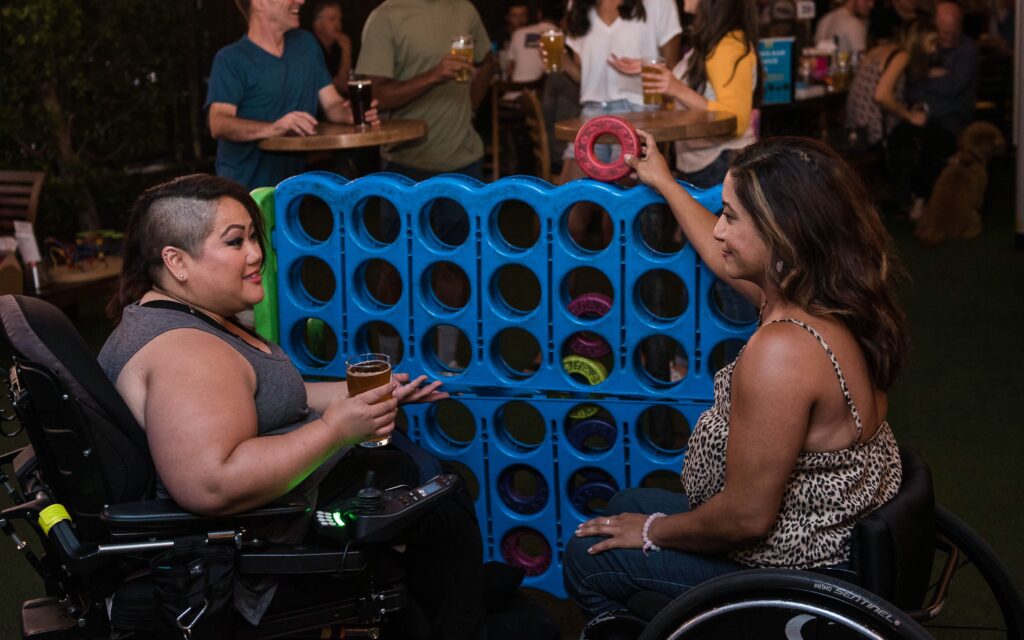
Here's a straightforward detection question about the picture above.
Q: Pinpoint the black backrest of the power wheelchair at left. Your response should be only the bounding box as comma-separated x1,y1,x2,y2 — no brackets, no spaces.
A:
0,295,155,538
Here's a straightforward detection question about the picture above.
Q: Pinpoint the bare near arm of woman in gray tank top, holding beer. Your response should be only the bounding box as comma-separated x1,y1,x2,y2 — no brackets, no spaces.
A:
125,330,396,514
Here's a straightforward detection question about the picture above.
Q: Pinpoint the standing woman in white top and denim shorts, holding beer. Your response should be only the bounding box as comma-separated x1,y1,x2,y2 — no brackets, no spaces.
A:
548,0,682,182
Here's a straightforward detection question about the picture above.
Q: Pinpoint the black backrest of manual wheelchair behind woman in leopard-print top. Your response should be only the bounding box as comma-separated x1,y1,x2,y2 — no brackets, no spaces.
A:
850,447,935,610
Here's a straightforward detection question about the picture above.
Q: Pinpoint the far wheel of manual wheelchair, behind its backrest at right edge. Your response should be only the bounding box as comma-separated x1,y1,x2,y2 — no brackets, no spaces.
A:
919,505,1024,640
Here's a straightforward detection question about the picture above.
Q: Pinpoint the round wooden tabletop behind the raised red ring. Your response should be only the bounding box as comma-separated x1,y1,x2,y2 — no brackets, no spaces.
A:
555,110,736,142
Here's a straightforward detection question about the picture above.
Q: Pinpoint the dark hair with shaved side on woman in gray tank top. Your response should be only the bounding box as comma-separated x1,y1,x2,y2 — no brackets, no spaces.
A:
106,173,266,322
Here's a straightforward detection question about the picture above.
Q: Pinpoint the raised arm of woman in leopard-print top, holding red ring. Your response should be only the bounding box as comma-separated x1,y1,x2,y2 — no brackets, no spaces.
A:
626,130,764,305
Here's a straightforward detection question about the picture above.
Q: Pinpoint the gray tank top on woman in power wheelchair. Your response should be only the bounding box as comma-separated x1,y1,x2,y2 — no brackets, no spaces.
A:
99,304,317,435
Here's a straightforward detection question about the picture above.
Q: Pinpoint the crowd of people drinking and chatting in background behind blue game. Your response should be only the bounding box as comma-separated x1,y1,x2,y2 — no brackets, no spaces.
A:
206,0,1014,217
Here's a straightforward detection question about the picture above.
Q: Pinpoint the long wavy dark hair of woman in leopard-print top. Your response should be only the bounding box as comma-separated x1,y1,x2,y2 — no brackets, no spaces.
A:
729,137,907,389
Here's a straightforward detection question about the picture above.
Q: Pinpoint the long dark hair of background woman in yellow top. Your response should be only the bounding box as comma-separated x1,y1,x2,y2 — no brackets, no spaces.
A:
684,0,761,92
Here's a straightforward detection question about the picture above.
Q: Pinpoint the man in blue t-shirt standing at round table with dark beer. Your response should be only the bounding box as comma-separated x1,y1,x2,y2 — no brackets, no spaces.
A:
206,0,378,188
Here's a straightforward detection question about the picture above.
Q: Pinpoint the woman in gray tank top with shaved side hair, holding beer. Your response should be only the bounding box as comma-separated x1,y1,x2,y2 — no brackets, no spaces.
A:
99,175,482,638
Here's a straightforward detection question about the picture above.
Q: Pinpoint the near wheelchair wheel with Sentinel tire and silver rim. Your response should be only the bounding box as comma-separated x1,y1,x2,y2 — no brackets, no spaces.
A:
640,569,932,640
